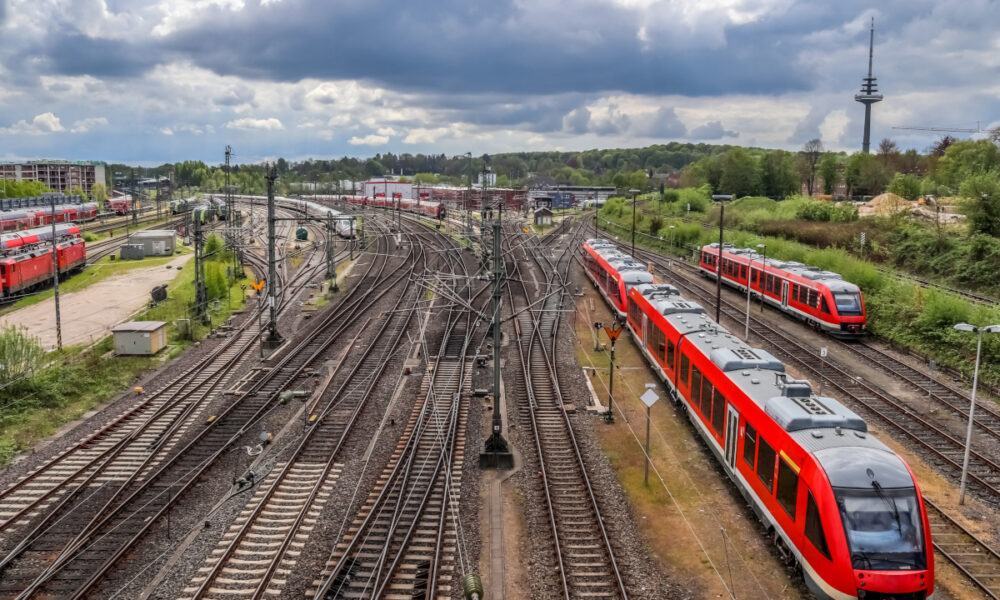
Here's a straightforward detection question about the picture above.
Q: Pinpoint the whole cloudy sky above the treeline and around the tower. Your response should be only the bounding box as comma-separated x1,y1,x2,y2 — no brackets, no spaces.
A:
0,0,1000,164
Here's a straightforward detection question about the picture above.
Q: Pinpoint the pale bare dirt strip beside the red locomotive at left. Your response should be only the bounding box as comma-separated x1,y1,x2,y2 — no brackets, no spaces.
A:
0,254,192,349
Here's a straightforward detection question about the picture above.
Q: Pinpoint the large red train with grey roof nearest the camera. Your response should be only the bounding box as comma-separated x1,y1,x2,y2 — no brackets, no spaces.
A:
583,240,934,600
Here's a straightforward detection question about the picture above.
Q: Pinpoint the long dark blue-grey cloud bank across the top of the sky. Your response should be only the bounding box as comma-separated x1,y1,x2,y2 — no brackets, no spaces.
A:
17,0,828,95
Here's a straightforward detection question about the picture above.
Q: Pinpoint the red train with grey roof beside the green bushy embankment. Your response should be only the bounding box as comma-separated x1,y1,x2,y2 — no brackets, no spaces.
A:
698,243,865,338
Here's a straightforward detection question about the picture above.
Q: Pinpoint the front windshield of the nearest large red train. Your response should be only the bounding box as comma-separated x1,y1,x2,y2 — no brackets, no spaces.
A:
834,483,927,571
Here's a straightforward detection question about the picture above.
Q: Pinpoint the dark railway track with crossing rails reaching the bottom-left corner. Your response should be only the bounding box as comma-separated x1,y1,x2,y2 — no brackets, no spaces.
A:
0,220,408,598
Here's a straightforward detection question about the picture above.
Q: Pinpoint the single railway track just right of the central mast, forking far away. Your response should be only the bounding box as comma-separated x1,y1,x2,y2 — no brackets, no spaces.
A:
508,221,628,600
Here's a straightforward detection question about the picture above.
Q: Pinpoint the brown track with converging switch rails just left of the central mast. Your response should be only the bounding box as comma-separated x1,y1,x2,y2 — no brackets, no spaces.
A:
309,223,482,599
